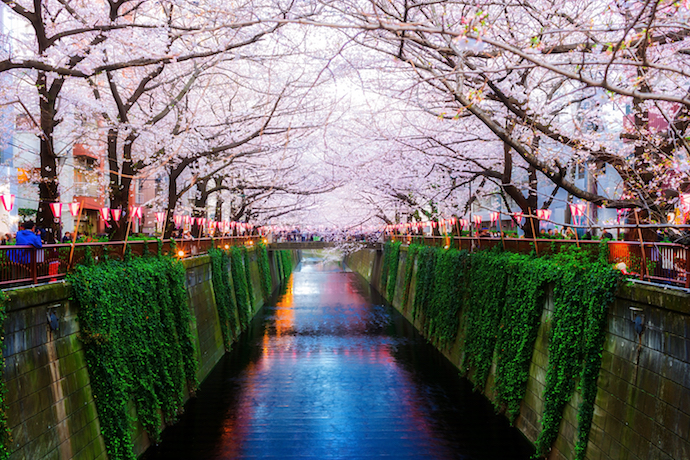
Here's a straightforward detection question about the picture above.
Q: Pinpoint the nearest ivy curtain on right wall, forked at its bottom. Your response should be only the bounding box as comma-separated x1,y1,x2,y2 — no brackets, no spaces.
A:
536,248,621,459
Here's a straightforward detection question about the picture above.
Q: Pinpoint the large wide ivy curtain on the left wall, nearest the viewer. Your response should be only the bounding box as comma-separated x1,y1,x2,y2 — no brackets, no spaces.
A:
68,257,198,459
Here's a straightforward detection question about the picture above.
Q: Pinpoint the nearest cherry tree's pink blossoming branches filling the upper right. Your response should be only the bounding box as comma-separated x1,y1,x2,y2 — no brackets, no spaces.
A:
323,0,690,226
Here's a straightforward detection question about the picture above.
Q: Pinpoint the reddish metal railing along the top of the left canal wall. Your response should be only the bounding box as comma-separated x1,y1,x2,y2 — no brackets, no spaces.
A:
0,236,260,288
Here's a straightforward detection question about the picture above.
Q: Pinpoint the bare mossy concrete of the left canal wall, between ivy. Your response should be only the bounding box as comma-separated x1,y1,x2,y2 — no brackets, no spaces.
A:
3,251,299,460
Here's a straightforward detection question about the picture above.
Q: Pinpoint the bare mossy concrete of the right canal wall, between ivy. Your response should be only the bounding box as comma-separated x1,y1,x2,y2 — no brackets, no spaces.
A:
346,248,690,460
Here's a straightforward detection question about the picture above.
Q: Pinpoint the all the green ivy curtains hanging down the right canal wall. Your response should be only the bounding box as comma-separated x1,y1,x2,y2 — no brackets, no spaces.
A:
392,245,621,460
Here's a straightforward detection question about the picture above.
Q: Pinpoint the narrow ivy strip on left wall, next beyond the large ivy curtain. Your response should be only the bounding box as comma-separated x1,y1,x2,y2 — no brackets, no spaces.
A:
208,248,238,350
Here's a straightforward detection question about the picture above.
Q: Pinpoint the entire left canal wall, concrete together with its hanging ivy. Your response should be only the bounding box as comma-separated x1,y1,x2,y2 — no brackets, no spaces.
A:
0,246,297,460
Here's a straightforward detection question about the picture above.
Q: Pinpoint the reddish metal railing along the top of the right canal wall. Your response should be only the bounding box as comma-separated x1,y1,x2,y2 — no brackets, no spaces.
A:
388,235,690,288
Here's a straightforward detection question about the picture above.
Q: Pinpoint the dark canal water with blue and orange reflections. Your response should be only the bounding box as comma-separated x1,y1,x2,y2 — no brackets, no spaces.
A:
144,253,533,460
